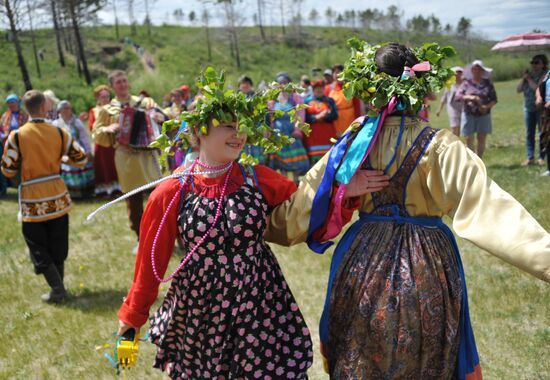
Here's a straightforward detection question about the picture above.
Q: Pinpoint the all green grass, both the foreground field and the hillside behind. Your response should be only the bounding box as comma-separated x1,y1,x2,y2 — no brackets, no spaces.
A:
0,26,550,380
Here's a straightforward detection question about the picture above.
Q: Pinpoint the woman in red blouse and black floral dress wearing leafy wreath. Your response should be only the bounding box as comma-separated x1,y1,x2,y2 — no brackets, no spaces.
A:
109,68,388,379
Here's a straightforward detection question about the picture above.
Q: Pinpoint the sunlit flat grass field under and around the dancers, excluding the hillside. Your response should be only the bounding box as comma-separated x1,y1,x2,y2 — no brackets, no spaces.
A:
0,82,550,380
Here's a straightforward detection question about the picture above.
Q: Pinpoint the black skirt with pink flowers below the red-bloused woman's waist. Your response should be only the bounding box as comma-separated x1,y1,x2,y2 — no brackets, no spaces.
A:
150,244,313,380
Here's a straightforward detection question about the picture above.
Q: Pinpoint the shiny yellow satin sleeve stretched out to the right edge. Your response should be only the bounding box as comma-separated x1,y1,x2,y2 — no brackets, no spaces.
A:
426,133,550,282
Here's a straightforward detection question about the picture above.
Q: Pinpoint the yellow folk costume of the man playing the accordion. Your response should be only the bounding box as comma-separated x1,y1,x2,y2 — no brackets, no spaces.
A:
92,96,161,239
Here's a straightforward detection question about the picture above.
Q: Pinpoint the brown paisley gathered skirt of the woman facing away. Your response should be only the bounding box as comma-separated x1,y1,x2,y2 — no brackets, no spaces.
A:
324,221,462,379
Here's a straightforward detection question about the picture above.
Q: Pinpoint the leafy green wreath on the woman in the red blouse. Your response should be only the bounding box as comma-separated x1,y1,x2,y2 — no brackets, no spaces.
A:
150,67,309,165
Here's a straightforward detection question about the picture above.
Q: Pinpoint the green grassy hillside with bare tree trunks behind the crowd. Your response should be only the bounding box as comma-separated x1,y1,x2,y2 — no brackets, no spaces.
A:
0,26,529,111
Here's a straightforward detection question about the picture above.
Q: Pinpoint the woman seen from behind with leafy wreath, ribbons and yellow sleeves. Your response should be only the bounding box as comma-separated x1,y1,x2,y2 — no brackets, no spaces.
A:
266,40,550,379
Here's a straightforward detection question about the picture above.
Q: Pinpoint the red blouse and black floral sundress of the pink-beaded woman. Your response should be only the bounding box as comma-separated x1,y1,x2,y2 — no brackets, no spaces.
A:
119,164,313,379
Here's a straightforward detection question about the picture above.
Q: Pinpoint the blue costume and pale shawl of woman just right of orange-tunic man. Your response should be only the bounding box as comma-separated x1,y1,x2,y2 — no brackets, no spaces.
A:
53,115,94,198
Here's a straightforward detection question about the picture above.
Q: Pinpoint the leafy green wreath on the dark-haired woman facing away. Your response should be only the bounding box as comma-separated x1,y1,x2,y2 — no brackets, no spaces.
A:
340,38,456,116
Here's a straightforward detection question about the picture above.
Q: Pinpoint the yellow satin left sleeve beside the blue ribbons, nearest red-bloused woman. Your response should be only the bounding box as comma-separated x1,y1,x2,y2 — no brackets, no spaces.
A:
265,154,329,246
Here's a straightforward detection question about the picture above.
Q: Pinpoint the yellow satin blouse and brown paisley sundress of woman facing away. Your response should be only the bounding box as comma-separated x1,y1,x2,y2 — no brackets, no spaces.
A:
266,117,550,378
